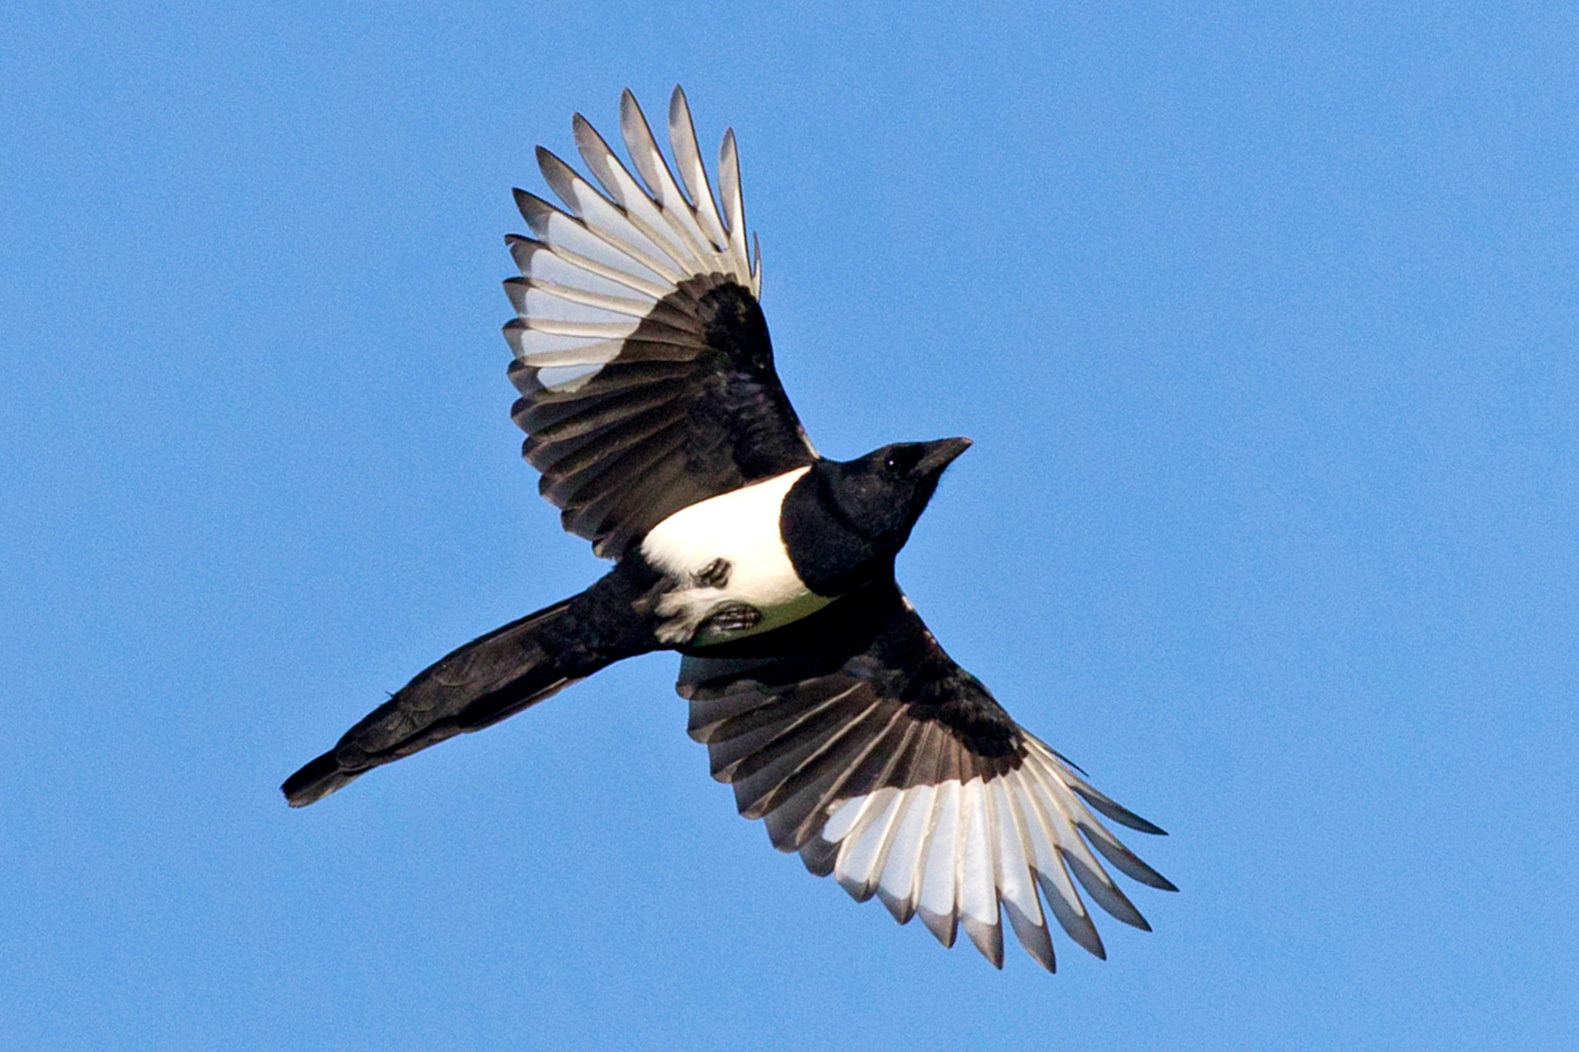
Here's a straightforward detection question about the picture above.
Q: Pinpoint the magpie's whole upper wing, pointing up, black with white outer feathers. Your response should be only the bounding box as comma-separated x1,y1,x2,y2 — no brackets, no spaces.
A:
504,88,816,558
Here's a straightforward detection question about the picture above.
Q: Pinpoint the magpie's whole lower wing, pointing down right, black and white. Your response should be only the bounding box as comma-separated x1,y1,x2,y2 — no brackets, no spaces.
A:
679,581,1175,970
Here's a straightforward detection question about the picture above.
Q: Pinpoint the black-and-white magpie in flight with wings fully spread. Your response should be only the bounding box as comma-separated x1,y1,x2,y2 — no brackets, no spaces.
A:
281,87,1175,971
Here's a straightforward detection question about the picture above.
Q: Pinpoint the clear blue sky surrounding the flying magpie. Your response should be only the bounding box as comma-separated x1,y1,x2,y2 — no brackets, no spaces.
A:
0,0,1579,1052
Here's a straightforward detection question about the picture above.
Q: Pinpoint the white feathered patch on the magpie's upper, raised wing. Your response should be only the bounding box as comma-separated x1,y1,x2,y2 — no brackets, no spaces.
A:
505,88,761,390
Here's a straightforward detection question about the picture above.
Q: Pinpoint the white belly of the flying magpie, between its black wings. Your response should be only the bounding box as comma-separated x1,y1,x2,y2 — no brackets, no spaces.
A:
641,468,832,644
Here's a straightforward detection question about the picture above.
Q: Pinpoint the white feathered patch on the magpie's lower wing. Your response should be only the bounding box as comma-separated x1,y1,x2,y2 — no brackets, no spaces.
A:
807,736,1173,970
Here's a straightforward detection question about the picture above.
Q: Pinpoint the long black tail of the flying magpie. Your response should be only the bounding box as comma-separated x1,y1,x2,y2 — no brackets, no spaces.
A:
279,575,628,807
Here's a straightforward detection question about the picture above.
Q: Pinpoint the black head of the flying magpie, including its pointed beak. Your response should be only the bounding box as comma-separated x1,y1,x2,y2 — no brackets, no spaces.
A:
824,438,971,554
